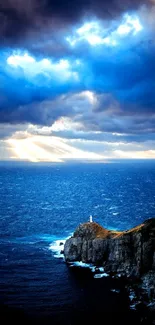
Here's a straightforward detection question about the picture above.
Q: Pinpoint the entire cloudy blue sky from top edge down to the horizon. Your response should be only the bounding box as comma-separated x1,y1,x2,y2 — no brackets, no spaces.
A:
0,0,155,163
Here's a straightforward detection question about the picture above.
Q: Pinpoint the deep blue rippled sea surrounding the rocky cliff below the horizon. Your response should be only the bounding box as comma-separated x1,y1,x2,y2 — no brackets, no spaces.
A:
0,161,155,324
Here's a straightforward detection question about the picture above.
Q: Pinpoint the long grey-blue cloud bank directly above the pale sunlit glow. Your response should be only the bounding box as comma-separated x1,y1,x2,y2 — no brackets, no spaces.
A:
2,88,155,142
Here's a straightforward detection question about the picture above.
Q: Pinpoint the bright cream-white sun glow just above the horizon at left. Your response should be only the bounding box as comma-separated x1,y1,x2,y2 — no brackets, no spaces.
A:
7,136,104,162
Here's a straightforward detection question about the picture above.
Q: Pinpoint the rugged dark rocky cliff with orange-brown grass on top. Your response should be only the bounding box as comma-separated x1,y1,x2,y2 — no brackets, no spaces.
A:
64,218,155,306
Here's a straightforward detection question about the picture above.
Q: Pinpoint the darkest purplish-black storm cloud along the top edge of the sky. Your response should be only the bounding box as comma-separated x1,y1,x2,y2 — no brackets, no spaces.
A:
0,0,150,46
